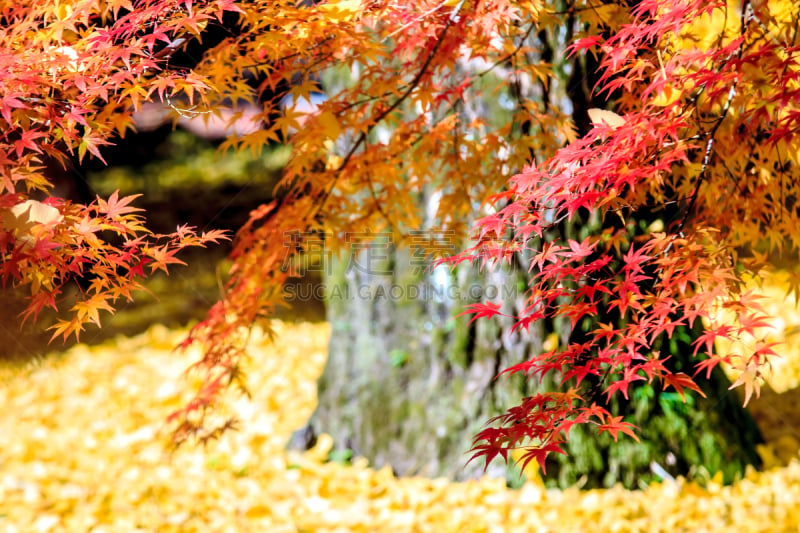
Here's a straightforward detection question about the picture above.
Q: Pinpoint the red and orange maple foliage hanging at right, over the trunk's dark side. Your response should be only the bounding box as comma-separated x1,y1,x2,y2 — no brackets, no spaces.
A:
457,0,800,468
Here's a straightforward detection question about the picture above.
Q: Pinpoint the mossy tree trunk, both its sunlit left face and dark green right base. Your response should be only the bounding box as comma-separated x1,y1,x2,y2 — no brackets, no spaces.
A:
293,240,760,488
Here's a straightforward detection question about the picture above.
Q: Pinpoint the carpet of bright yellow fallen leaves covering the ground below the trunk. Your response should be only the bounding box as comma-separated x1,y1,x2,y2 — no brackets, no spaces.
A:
0,323,800,533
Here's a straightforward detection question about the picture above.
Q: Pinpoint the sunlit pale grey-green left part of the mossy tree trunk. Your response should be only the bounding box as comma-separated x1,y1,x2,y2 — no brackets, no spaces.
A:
294,243,543,479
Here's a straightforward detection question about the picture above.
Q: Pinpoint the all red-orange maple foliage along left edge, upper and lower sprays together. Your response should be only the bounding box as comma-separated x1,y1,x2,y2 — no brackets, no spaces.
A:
0,0,235,338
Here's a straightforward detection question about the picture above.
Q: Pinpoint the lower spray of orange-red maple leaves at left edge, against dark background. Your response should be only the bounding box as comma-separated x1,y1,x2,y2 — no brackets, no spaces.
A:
0,193,223,339
